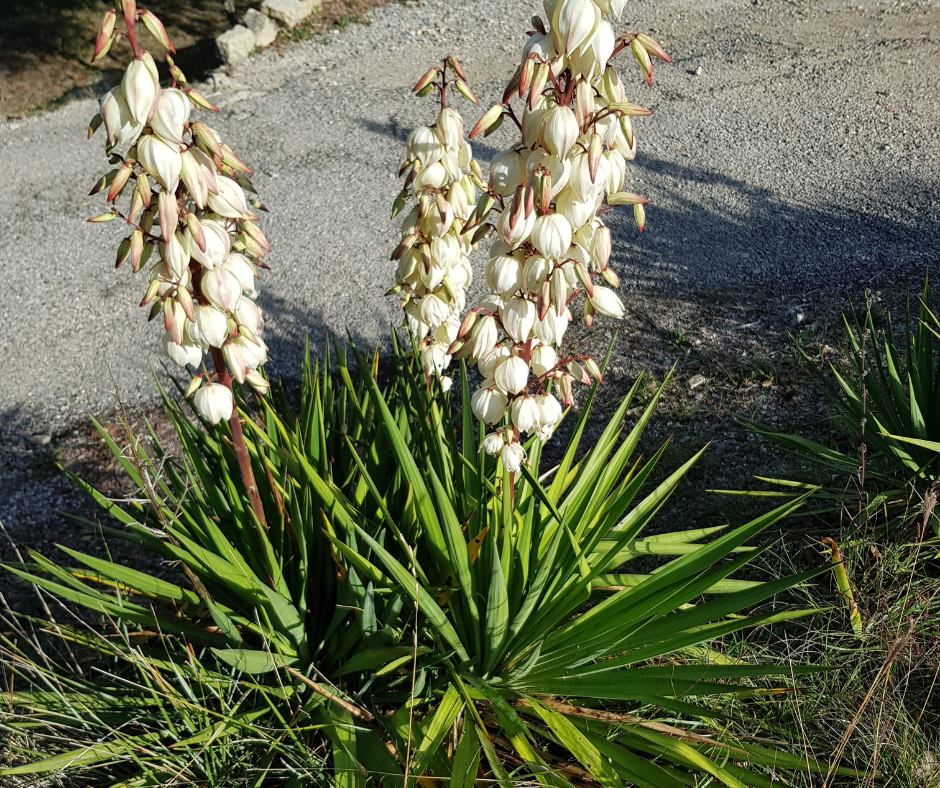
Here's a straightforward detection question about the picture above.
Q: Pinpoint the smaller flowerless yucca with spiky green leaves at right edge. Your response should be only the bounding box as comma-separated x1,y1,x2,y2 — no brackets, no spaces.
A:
745,278,940,536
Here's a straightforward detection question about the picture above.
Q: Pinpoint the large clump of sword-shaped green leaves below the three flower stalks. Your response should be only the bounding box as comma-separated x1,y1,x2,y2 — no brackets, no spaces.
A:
0,340,852,788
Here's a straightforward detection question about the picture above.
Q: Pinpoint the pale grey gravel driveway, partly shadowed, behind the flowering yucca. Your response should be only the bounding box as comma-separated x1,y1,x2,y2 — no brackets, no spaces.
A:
0,0,940,568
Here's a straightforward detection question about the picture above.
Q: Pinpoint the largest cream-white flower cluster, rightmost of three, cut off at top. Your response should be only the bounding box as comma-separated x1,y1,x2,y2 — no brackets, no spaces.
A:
448,0,669,472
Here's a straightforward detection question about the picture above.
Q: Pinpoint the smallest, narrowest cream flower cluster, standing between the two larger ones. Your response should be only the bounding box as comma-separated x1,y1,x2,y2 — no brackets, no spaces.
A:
389,57,485,390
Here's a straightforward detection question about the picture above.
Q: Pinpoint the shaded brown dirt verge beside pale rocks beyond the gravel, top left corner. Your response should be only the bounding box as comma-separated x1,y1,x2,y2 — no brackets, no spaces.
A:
0,0,411,118
